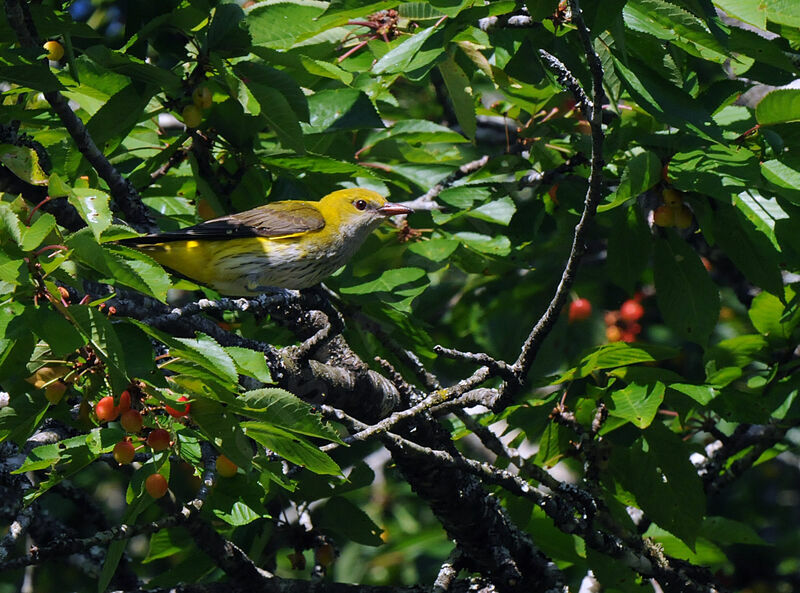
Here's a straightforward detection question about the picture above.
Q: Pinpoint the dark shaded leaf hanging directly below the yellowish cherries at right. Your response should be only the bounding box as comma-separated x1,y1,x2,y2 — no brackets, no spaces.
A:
653,232,719,345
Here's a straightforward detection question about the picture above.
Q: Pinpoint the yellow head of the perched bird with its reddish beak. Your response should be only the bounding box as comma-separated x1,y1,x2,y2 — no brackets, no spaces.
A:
319,187,413,236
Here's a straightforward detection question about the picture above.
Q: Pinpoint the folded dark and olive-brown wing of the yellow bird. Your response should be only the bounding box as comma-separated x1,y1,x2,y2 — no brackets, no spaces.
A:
125,200,325,245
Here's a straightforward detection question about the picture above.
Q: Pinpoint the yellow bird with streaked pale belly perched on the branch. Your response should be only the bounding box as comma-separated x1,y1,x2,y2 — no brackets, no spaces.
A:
125,188,413,296
